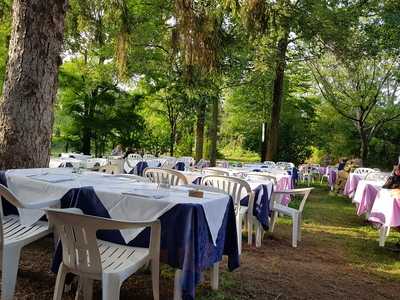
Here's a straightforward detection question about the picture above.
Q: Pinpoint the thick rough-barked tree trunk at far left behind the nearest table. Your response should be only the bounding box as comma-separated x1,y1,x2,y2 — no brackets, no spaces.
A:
0,0,67,169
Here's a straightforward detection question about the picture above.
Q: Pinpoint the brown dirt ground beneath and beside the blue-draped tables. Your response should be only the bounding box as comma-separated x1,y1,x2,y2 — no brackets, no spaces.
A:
7,188,400,300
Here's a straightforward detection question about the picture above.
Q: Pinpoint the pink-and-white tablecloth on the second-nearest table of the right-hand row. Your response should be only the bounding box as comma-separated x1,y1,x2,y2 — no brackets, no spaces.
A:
353,180,381,216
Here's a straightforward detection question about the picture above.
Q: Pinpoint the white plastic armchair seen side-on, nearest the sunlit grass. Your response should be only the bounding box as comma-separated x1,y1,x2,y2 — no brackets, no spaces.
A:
270,188,313,247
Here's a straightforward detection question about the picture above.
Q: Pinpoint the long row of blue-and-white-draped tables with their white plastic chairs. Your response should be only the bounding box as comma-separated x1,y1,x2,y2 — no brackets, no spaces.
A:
0,153,311,300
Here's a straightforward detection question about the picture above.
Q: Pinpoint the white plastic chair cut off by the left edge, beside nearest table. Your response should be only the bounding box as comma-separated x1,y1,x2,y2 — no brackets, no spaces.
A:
0,184,53,300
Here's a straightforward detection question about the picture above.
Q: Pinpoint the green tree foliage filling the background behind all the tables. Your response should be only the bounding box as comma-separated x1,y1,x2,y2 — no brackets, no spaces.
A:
0,0,400,166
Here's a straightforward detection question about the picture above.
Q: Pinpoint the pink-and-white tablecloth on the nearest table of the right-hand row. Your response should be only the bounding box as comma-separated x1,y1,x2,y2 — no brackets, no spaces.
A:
368,189,400,227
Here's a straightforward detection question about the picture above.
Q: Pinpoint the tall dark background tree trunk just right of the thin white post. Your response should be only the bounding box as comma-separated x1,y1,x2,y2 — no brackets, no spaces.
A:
266,31,289,161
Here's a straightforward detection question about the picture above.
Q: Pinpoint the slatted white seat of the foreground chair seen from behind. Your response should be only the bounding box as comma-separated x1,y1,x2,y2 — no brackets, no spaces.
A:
97,240,150,276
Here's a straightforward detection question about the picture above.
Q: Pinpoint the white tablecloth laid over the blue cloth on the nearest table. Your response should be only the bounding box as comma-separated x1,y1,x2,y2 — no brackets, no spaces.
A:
6,168,229,244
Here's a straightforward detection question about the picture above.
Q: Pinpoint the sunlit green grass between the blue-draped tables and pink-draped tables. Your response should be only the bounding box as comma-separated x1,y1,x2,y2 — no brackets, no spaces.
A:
303,186,400,280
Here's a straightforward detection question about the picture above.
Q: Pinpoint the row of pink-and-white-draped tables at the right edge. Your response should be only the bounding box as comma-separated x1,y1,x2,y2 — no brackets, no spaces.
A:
343,173,400,247
